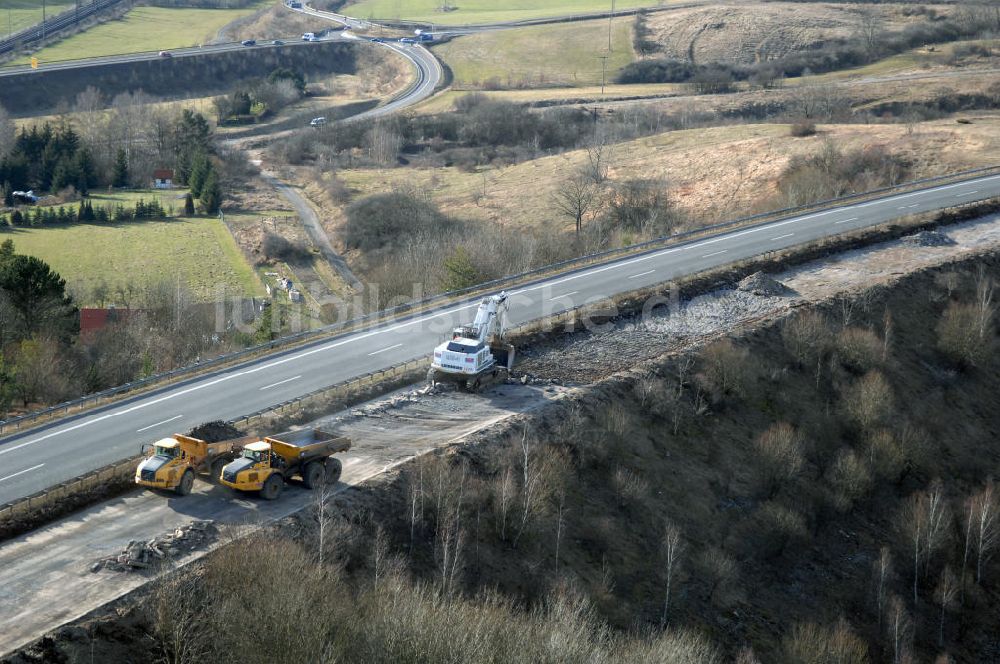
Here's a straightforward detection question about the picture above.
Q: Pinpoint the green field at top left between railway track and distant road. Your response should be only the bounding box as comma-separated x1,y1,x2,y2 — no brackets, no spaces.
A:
14,0,271,64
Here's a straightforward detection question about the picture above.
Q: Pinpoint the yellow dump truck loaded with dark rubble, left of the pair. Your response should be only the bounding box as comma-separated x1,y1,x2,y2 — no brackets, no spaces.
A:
135,433,260,496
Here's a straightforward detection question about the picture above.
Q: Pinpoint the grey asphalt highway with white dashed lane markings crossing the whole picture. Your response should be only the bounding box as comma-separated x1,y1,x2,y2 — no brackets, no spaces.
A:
0,175,1000,503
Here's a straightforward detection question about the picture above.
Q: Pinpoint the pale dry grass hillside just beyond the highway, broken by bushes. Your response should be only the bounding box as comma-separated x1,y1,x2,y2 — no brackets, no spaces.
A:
316,113,1000,237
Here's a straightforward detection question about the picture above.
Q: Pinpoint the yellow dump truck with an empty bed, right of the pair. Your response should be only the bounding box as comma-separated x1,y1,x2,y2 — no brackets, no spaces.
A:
221,429,351,500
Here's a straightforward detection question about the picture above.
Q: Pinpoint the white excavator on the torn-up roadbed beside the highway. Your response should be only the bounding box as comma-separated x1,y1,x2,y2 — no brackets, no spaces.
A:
427,292,514,391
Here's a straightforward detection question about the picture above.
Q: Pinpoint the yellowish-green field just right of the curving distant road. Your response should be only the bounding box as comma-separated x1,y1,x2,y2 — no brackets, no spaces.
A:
434,18,635,88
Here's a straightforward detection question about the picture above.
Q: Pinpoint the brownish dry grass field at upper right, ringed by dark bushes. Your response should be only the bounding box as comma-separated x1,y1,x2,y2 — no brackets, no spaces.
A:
647,2,949,64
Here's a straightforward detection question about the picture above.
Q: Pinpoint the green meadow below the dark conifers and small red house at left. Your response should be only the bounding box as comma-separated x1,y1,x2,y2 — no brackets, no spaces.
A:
0,204,263,304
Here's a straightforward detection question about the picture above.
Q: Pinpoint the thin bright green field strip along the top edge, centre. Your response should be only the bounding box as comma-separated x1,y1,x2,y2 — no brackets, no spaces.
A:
342,0,664,25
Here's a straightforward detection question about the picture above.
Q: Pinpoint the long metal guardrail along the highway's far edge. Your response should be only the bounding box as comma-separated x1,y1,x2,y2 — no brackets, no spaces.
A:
0,164,1000,436
